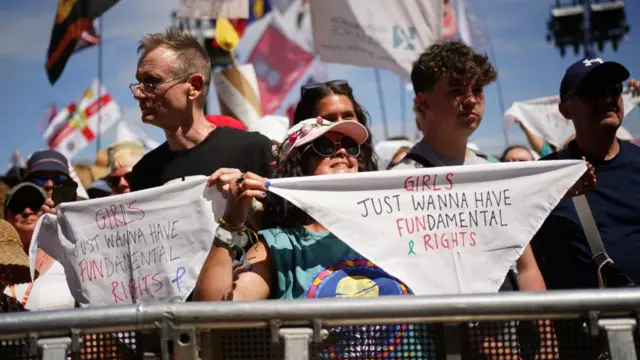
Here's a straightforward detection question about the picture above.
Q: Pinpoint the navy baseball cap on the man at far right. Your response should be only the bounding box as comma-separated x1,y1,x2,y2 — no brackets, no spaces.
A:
560,58,630,101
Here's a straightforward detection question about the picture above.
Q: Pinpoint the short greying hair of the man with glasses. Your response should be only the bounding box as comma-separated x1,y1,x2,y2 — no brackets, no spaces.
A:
138,27,211,99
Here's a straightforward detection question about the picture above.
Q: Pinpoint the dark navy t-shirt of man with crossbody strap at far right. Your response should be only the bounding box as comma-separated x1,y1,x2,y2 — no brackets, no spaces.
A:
531,141,640,289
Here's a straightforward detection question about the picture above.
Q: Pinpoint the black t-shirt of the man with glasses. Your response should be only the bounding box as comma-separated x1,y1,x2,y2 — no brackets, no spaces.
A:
129,127,274,191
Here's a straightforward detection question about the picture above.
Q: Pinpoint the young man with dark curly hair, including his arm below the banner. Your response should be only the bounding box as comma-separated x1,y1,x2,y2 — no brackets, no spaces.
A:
393,41,546,358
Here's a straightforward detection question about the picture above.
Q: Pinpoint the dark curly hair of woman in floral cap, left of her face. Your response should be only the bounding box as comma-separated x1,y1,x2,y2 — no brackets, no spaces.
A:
262,148,312,229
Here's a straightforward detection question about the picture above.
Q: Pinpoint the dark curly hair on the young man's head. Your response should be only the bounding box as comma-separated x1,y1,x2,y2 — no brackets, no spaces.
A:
411,41,498,95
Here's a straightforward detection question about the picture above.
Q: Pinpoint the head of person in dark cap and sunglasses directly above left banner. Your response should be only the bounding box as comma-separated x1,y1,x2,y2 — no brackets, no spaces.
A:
24,150,69,199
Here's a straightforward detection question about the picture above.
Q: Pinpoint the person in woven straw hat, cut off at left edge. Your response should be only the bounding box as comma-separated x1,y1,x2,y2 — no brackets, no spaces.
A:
0,219,31,312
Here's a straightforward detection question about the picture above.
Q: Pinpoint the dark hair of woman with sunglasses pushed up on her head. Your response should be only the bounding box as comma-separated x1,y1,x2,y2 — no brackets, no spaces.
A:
293,81,378,172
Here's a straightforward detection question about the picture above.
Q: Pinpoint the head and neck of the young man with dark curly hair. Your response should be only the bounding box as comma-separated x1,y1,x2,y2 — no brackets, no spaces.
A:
392,42,498,166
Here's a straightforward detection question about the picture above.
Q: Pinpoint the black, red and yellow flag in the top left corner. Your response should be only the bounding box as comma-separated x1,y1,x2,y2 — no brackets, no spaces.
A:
45,0,118,85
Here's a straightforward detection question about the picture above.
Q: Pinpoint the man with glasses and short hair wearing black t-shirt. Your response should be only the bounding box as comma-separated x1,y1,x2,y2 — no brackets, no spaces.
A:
127,28,273,191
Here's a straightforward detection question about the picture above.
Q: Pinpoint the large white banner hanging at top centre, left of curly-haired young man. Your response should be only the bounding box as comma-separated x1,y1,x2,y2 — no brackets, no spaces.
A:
310,0,442,78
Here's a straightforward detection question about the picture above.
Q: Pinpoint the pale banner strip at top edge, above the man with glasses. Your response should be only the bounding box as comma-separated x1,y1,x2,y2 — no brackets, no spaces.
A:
177,0,249,19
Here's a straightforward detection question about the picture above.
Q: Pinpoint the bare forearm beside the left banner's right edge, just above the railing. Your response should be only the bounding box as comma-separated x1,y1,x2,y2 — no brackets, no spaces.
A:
193,246,238,301
